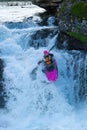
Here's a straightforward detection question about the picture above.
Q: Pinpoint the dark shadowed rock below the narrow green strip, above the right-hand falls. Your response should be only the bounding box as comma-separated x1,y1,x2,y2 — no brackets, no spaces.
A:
57,32,87,50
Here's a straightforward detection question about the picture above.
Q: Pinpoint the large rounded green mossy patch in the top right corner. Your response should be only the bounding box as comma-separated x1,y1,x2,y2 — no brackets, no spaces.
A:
70,2,87,19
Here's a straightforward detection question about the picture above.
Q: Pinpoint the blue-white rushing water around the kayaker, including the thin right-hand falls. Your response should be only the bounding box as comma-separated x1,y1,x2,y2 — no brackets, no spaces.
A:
0,2,87,130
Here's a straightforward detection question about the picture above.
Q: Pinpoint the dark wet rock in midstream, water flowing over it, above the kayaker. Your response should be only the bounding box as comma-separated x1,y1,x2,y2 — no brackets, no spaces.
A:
29,28,58,49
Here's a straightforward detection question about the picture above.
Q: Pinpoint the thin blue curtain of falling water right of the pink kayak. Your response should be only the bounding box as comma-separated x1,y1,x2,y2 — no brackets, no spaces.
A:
57,51,87,104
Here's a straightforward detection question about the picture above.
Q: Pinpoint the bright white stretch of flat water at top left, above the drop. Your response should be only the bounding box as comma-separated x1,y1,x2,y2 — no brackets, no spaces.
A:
0,2,45,22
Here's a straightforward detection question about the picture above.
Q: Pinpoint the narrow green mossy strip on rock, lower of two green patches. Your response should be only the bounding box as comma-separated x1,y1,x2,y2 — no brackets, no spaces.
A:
67,32,87,43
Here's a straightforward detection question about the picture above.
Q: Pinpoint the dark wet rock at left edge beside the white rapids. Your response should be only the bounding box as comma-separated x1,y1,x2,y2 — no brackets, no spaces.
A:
0,59,5,108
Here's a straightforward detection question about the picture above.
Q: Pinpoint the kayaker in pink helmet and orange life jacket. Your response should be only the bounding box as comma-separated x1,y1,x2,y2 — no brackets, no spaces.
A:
38,50,54,73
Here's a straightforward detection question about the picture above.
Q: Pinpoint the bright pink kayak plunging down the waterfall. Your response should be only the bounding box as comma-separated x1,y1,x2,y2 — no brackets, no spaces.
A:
45,61,58,82
